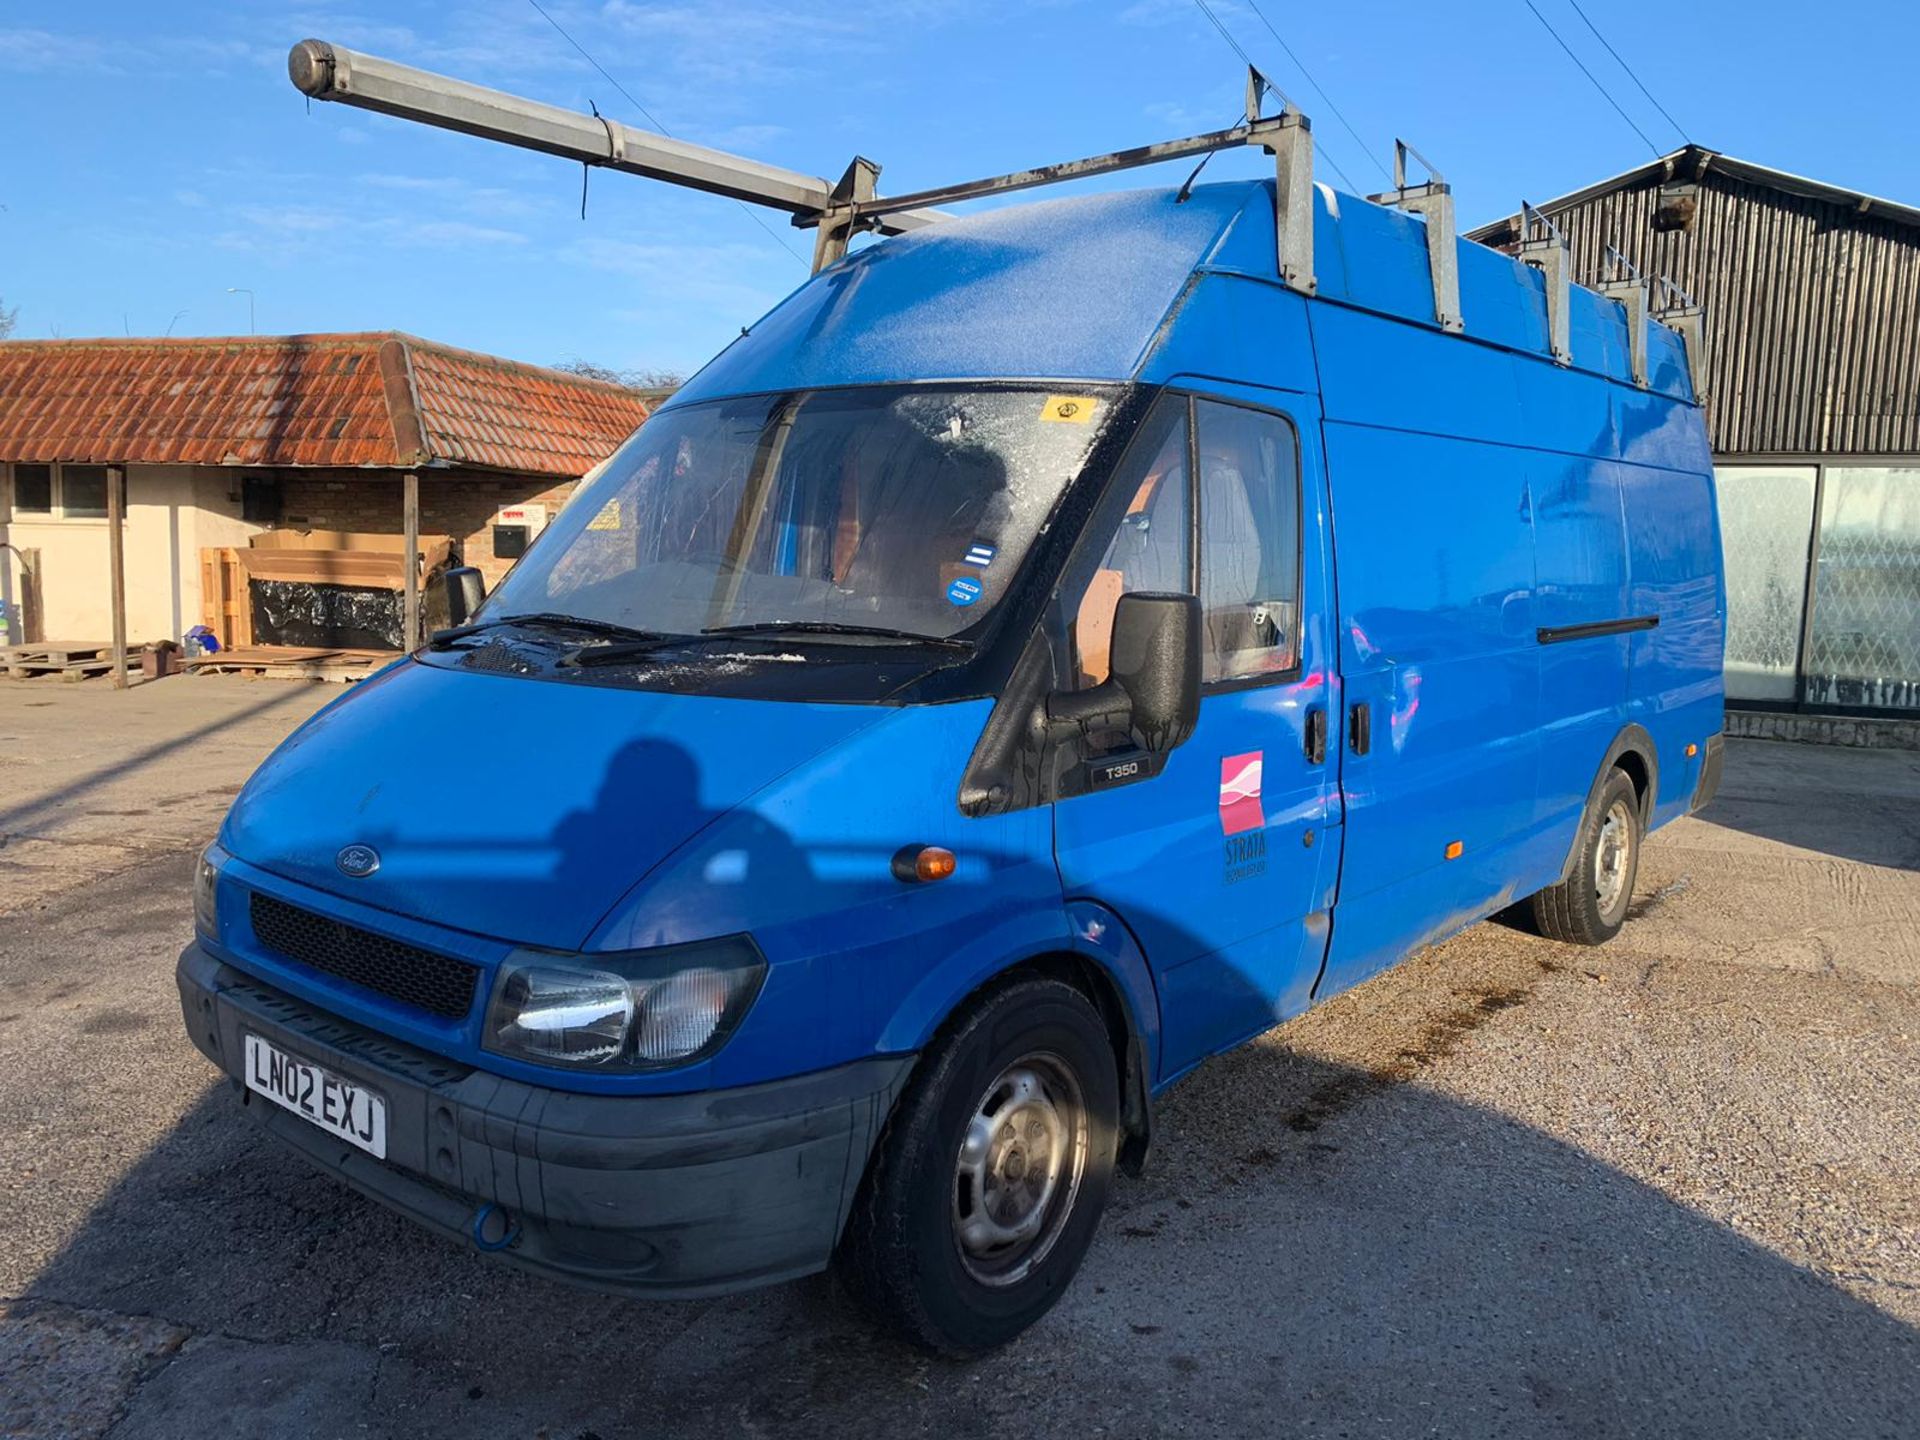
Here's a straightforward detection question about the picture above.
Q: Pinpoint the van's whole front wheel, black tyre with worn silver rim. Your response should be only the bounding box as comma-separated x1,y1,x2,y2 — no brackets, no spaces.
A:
835,977,1119,1357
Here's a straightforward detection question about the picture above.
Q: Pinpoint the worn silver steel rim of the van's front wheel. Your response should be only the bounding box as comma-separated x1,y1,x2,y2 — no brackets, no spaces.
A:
952,1052,1089,1286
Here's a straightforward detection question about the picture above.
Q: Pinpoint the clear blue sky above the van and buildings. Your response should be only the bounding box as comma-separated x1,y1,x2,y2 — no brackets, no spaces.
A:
0,0,1920,371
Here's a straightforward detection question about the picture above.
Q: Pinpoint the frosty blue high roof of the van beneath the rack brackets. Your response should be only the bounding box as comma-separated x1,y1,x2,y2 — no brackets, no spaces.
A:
672,180,1692,405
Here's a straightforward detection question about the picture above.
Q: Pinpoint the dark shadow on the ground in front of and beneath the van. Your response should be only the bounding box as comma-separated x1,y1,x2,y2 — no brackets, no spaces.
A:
31,991,1920,1440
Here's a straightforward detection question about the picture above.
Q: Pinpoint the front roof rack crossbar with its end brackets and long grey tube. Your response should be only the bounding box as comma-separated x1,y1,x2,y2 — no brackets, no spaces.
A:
286,40,1320,286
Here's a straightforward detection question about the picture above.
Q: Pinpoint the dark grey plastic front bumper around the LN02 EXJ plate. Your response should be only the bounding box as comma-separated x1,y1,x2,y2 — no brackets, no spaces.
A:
179,945,914,1298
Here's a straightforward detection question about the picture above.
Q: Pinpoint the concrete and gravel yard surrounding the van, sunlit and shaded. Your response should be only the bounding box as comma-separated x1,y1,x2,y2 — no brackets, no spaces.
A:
0,678,1920,1440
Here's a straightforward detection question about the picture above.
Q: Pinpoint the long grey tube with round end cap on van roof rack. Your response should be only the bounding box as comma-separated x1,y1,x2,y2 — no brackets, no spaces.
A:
286,40,945,234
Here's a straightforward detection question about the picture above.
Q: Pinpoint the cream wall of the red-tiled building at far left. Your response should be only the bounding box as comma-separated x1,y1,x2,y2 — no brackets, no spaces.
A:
0,465,259,647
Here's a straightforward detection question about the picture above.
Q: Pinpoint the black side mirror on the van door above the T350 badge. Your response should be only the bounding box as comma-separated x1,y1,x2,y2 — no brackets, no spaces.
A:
1046,591,1200,755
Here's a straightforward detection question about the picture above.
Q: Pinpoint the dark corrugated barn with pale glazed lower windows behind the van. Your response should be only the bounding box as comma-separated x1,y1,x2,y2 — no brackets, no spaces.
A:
1471,146,1920,716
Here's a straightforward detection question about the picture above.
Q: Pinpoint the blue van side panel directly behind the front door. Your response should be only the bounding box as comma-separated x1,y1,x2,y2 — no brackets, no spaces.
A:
1311,305,1543,998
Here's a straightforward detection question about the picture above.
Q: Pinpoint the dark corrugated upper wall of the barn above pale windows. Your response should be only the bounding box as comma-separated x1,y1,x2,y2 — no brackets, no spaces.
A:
1497,167,1920,455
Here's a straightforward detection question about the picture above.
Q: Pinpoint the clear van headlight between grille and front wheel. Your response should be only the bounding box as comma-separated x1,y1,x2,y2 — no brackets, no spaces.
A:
484,935,766,1069
